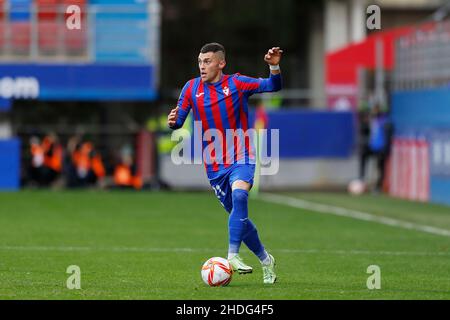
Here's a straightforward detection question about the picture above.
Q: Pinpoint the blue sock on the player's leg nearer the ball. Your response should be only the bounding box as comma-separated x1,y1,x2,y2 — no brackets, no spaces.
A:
228,189,248,254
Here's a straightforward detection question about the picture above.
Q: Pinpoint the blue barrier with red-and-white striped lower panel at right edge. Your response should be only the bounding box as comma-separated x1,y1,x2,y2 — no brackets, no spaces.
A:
389,87,450,204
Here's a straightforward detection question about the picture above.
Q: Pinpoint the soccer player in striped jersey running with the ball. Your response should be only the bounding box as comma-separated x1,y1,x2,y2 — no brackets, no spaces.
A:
167,43,283,284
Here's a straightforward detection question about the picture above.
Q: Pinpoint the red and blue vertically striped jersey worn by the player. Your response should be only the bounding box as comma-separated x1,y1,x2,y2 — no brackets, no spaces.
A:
171,73,281,172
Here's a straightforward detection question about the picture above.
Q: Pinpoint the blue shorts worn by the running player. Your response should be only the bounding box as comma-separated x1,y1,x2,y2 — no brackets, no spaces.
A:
207,163,255,213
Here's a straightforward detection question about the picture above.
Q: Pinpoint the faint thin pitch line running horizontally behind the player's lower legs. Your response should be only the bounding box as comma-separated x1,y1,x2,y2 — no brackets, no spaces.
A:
0,246,450,256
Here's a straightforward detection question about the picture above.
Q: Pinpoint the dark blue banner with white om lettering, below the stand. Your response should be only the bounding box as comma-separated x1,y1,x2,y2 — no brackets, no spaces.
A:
0,64,156,101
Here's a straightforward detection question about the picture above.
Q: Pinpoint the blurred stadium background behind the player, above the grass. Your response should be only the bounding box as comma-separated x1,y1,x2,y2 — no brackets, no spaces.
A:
0,0,450,204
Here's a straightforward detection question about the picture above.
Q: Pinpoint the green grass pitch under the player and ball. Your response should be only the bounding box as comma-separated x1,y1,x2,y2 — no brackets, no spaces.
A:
0,191,450,300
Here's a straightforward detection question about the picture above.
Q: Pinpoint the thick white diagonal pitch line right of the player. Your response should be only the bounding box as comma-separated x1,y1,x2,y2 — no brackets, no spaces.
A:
259,193,450,237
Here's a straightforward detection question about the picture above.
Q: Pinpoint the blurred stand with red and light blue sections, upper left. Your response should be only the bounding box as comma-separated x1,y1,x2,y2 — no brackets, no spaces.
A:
0,0,153,64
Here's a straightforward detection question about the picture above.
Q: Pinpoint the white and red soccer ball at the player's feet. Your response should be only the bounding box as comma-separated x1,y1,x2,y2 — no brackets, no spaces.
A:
201,257,233,287
